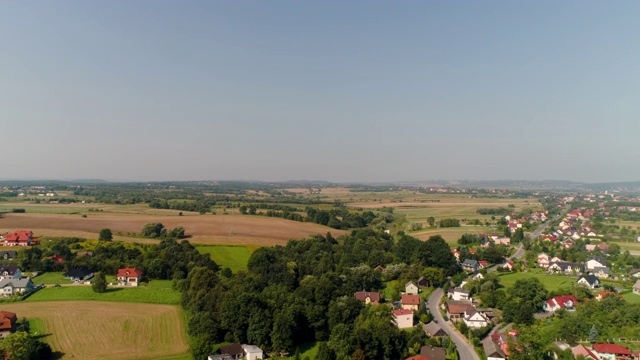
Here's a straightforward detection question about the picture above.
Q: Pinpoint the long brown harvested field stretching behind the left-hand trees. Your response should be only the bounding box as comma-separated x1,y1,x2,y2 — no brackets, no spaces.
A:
0,213,346,246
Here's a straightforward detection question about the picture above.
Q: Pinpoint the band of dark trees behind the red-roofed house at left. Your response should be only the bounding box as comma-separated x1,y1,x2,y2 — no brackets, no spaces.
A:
17,238,218,279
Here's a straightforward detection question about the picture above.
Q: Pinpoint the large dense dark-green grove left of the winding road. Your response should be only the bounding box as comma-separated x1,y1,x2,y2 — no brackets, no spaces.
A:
175,229,459,359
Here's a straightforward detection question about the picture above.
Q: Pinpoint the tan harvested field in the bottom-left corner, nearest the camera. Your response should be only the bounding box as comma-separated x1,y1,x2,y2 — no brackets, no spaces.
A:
2,301,189,360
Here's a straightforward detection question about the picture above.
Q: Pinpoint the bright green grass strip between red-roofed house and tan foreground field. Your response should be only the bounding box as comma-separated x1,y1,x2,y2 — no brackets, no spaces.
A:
25,280,180,305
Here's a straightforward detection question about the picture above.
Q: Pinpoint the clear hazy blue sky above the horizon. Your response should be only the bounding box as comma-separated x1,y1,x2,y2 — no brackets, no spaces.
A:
0,0,640,182
